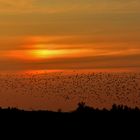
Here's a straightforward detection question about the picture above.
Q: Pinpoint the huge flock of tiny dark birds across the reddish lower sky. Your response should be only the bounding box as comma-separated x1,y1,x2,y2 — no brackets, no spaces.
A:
0,71,140,108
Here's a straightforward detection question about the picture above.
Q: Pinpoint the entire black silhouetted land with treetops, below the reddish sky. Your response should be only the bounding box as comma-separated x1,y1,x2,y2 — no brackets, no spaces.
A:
0,103,140,139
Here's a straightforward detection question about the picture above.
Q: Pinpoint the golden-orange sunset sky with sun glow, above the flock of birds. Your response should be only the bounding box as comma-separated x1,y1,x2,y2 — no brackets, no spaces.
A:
0,0,140,70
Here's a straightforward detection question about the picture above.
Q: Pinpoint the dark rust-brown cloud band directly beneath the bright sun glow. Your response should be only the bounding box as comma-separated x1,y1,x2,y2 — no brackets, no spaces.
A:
0,52,140,70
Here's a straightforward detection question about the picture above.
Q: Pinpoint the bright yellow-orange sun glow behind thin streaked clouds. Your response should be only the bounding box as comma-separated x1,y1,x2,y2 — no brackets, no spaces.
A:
24,43,88,59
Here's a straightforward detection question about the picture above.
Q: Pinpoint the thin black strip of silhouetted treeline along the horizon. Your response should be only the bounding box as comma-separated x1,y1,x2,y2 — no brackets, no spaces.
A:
0,102,140,114
